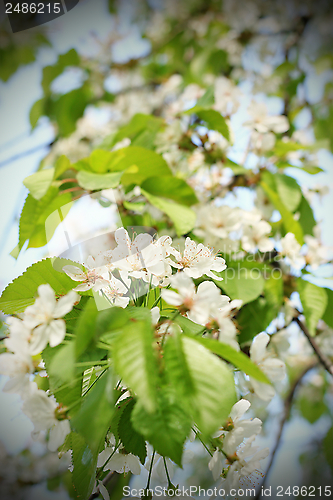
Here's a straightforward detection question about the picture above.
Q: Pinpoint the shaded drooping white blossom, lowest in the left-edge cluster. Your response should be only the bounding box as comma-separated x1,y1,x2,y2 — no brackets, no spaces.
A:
22,389,71,451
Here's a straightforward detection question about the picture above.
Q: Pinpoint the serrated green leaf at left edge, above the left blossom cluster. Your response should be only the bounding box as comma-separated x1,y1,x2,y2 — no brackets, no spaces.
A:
0,259,78,314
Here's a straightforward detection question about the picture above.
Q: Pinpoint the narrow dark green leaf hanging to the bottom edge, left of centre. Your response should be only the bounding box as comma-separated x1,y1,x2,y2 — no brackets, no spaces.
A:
70,432,97,500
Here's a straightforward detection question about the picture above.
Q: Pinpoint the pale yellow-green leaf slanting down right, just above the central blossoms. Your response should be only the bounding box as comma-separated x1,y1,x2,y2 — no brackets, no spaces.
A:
142,189,197,236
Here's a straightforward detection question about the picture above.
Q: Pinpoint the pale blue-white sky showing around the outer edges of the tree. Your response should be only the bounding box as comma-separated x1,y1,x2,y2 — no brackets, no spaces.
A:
0,0,333,494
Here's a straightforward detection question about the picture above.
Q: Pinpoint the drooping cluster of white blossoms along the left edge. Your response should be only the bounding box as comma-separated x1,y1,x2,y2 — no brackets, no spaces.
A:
0,284,80,451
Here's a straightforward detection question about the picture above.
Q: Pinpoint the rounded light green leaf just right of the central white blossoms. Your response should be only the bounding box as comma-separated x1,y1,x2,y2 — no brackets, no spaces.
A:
216,268,265,304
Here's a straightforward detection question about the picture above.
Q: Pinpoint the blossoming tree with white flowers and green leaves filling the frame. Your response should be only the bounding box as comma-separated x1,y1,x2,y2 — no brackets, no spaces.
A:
0,0,333,499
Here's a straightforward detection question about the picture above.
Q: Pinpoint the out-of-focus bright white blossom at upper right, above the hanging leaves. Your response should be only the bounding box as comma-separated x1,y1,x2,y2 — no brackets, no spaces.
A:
244,101,289,134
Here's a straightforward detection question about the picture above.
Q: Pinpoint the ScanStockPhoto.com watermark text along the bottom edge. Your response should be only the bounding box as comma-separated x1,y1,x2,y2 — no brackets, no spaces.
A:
123,486,256,499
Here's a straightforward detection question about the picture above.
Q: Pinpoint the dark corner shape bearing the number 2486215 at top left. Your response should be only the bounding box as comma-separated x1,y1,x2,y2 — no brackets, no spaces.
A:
0,0,80,33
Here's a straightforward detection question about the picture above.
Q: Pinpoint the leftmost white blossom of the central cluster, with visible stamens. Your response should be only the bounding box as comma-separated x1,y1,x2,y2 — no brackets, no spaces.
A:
62,257,108,292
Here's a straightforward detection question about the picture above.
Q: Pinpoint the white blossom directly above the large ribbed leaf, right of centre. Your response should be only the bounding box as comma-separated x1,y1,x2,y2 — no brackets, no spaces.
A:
161,272,223,325
